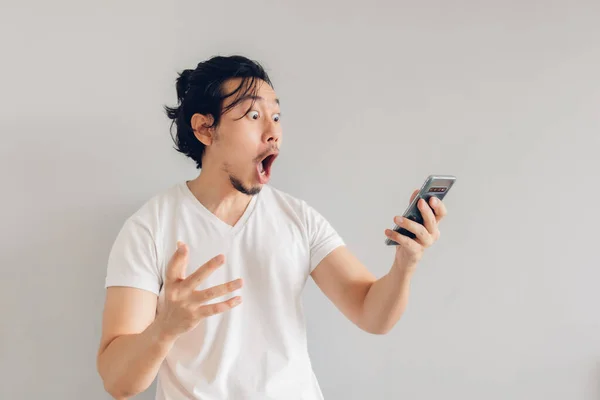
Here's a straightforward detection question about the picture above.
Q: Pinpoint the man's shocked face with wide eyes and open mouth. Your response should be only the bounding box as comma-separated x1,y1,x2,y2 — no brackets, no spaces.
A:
203,80,282,195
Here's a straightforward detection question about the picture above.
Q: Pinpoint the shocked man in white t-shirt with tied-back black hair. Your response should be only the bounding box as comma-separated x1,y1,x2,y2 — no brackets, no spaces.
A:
98,56,446,400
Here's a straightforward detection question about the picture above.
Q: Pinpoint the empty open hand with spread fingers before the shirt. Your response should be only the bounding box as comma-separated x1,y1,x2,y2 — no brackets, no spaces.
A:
156,242,242,339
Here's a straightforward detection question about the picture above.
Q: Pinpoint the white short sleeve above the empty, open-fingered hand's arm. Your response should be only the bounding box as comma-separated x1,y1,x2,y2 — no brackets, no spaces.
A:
105,218,162,295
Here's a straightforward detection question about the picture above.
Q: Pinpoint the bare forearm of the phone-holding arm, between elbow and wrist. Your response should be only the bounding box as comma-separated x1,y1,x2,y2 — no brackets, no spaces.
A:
361,265,413,334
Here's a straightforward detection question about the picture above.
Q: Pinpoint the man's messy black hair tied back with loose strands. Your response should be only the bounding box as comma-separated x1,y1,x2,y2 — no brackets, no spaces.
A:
165,55,273,169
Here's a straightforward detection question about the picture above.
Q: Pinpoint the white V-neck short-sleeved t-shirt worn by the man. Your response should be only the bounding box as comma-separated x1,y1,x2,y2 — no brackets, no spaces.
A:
106,182,344,400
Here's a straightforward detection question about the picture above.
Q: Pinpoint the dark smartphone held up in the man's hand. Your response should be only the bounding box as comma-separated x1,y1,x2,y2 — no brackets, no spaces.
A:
385,175,456,246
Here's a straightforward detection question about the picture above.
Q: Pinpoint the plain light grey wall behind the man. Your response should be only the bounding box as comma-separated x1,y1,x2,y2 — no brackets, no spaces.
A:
0,0,600,400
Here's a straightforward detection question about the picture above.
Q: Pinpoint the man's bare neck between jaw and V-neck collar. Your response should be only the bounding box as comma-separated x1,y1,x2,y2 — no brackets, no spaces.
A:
187,168,252,225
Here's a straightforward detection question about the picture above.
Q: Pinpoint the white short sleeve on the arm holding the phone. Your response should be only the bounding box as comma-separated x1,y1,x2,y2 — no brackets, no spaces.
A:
306,206,344,272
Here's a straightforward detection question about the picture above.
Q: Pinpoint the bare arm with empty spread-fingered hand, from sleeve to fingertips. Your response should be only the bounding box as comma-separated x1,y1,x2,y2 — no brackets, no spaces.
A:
97,243,242,399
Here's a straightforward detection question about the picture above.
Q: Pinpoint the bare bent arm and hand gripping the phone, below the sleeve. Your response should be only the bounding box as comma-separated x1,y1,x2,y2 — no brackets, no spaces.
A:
311,191,446,334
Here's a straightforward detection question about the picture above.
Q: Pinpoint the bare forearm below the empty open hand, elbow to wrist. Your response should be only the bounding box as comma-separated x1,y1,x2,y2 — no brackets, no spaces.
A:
98,321,174,399
